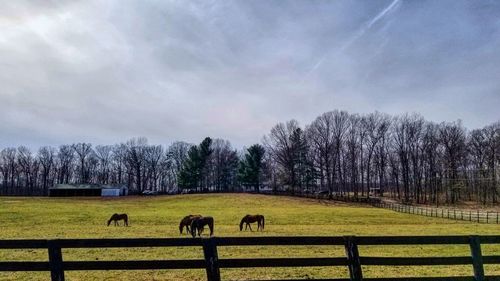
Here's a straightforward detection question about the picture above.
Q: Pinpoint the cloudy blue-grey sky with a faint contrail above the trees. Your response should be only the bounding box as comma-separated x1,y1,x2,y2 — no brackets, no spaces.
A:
0,0,500,147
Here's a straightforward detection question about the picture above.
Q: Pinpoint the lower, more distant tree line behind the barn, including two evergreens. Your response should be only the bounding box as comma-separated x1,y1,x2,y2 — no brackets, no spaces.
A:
0,137,263,195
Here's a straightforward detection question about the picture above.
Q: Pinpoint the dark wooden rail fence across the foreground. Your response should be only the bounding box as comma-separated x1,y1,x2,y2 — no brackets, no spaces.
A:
0,235,500,281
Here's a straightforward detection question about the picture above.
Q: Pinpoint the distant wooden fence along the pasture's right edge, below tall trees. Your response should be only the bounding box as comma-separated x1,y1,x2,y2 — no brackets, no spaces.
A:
372,202,500,224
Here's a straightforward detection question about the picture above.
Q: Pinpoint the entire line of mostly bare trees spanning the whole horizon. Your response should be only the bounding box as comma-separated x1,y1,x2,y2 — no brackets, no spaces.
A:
0,110,500,204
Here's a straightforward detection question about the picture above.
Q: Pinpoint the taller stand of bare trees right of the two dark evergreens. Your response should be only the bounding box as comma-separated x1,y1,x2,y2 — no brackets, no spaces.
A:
264,110,500,204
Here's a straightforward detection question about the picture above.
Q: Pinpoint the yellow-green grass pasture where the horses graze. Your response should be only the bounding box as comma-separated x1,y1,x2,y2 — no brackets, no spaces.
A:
0,194,500,280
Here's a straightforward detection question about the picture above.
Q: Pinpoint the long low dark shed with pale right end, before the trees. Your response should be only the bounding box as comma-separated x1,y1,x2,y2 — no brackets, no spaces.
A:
49,184,128,197
